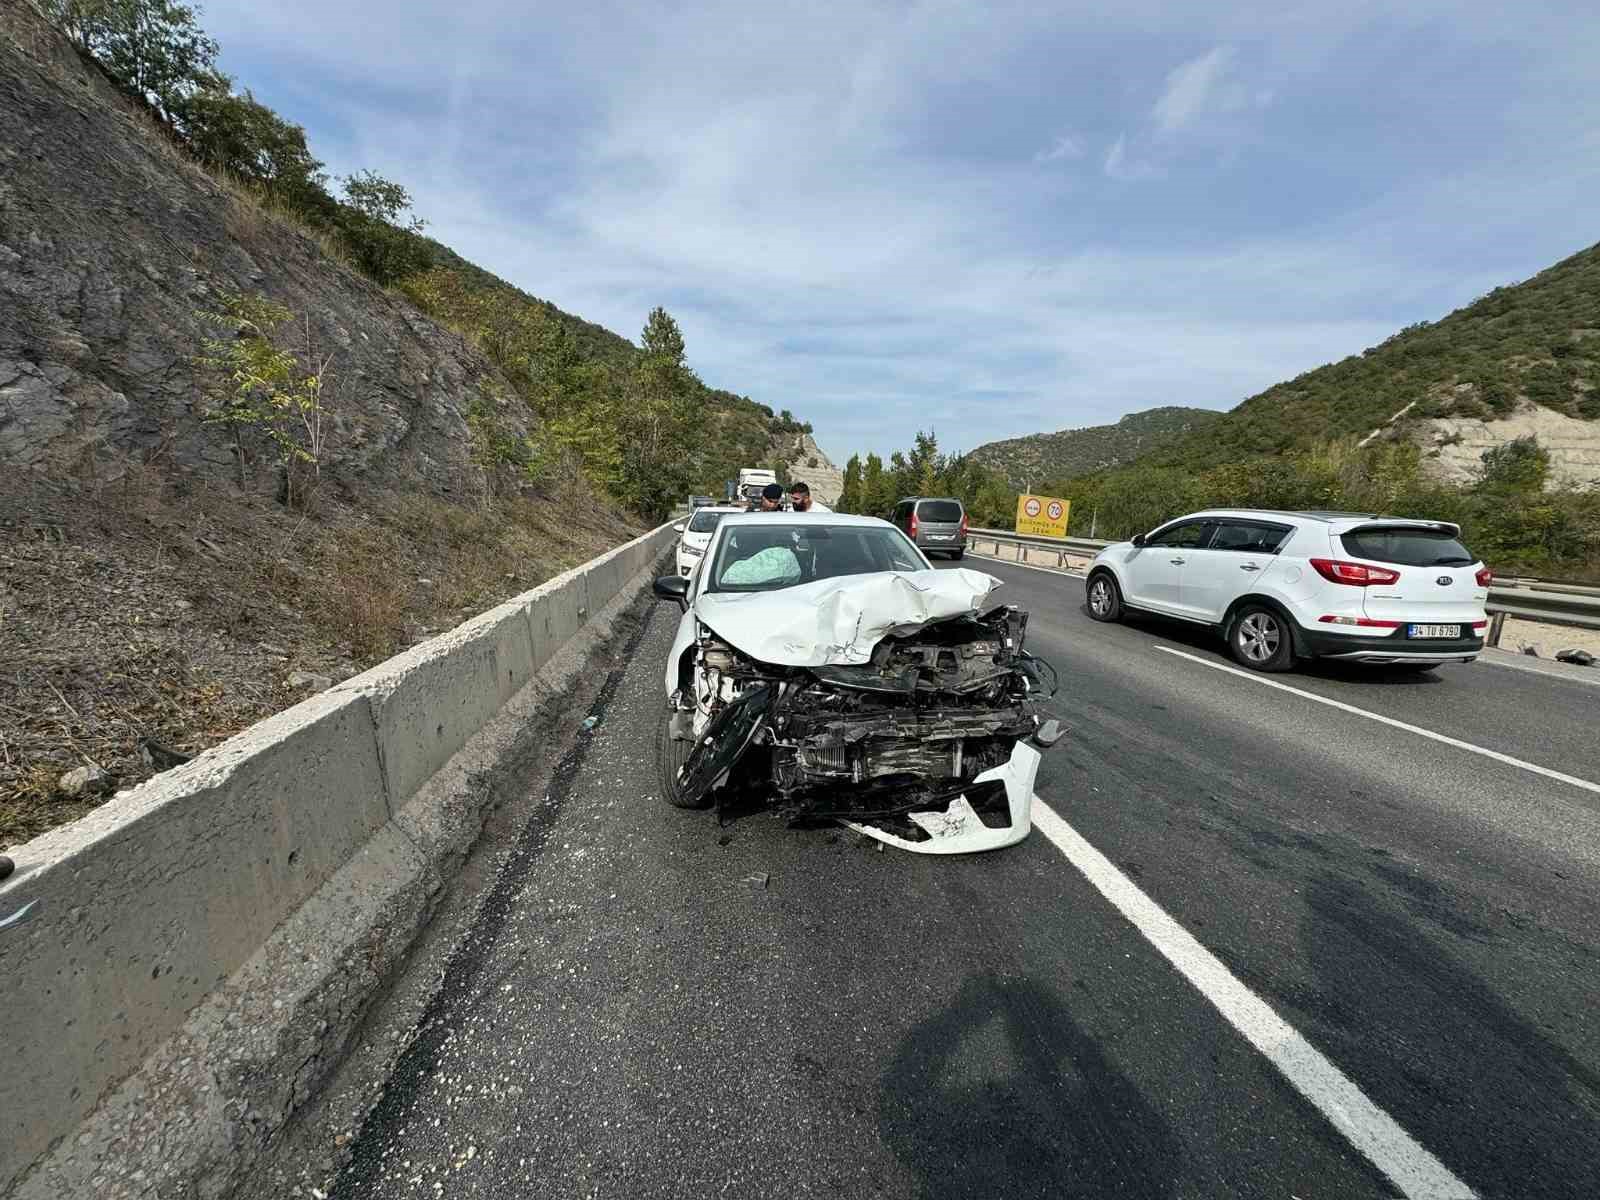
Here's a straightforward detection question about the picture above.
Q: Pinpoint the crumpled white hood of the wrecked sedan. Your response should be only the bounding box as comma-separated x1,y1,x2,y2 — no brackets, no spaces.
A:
694,568,1002,667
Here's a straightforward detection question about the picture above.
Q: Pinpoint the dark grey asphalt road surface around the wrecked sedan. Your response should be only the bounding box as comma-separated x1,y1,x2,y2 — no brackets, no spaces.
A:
284,558,1600,1200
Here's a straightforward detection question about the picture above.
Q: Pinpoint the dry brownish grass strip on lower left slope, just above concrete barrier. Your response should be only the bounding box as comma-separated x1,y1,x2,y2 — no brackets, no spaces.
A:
0,448,638,846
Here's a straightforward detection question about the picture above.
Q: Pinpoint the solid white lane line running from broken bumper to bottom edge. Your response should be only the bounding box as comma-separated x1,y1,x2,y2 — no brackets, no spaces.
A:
1034,795,1474,1200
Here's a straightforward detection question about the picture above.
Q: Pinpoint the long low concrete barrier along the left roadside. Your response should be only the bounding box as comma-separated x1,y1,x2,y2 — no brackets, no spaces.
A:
0,526,675,1200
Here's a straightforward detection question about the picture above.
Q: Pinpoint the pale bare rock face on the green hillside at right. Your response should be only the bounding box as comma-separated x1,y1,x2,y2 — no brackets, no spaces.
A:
1413,400,1600,488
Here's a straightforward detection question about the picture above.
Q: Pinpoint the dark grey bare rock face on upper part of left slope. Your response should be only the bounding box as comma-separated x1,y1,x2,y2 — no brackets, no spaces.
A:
0,0,522,493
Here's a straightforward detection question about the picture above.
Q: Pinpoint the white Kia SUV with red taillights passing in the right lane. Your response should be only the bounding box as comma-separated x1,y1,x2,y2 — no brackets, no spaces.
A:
1088,509,1491,670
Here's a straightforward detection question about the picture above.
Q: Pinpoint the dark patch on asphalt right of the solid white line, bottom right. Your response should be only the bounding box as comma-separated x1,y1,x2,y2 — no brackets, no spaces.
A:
1293,869,1600,1200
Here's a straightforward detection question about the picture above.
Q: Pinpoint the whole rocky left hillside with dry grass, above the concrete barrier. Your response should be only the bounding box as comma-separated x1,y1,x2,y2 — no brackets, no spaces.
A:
0,0,802,848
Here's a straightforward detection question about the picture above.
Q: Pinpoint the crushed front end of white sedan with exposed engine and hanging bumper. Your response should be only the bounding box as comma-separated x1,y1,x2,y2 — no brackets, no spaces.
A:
664,605,1061,853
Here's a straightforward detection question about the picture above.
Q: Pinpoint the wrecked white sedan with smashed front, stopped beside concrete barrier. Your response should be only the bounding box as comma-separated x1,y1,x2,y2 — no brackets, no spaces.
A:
654,514,1061,854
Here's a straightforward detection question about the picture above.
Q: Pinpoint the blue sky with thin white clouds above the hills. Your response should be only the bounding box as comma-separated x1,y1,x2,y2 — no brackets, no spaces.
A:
202,0,1600,462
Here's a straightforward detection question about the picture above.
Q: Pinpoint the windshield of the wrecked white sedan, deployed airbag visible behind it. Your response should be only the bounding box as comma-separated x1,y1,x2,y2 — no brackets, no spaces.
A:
706,520,928,592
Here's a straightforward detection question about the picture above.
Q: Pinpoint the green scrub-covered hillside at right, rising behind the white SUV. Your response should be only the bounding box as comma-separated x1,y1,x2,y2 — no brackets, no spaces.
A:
1132,246,1600,475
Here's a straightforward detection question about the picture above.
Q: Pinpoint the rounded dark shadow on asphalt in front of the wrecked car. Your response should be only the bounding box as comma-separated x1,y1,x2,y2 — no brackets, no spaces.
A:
878,973,1182,1200
